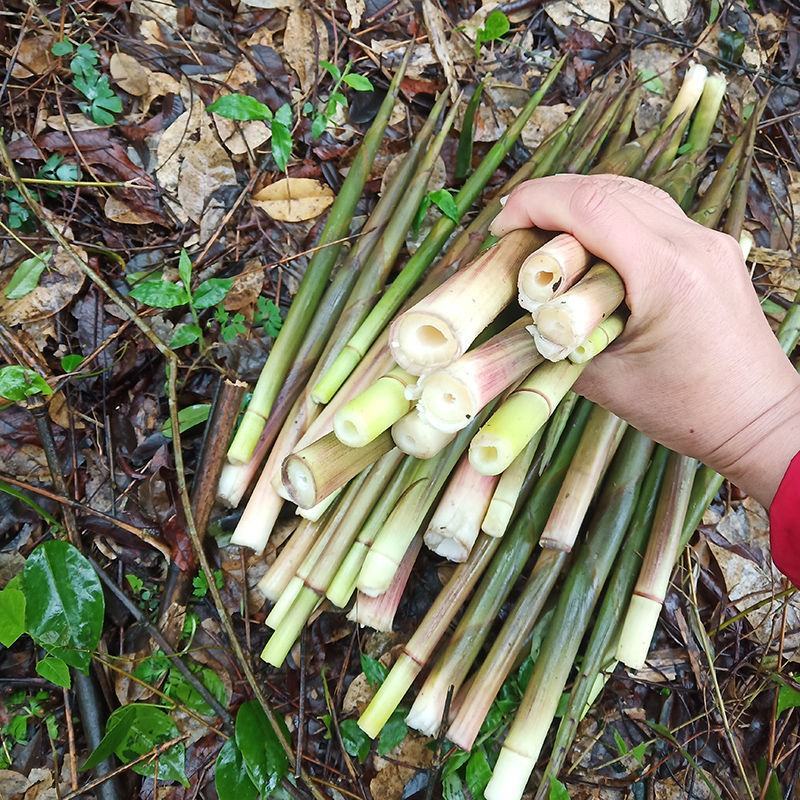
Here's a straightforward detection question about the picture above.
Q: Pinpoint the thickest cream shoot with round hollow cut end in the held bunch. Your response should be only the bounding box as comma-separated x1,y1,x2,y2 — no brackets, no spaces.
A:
389,229,546,375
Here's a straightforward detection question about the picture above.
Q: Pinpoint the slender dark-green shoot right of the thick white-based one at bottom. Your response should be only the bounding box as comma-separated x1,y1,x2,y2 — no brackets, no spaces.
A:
534,447,669,800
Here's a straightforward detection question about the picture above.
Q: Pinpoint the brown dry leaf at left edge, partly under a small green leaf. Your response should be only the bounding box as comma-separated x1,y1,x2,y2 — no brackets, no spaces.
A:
0,247,86,325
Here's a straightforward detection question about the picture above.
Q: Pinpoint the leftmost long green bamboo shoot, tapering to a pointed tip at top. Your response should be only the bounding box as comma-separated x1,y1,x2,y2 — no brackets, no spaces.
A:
228,46,412,464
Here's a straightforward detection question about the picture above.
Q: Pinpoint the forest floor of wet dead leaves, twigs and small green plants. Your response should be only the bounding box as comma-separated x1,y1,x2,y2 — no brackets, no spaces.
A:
0,0,800,800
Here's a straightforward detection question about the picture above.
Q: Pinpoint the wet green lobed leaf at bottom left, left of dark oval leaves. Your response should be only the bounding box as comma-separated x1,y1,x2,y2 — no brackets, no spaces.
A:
81,703,189,786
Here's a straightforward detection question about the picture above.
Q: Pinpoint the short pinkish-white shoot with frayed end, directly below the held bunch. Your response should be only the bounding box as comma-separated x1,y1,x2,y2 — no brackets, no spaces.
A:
425,454,500,562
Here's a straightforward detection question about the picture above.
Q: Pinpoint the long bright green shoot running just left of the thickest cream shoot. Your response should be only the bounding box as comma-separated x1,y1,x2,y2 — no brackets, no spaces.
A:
312,57,565,403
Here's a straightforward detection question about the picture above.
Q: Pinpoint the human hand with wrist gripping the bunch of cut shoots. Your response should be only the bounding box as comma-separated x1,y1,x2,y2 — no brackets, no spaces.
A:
491,175,800,506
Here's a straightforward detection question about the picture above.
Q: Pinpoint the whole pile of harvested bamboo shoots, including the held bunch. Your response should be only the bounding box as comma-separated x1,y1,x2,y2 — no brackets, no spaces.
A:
220,57,759,800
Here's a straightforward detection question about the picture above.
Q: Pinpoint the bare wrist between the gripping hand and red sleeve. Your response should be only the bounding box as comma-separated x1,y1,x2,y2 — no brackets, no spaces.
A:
706,374,800,508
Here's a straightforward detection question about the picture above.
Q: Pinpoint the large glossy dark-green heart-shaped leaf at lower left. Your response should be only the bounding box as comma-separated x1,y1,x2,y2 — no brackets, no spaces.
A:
22,541,105,672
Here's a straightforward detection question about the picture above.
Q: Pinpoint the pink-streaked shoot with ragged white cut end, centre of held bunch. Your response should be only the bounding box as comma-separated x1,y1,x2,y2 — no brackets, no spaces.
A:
417,319,543,433
